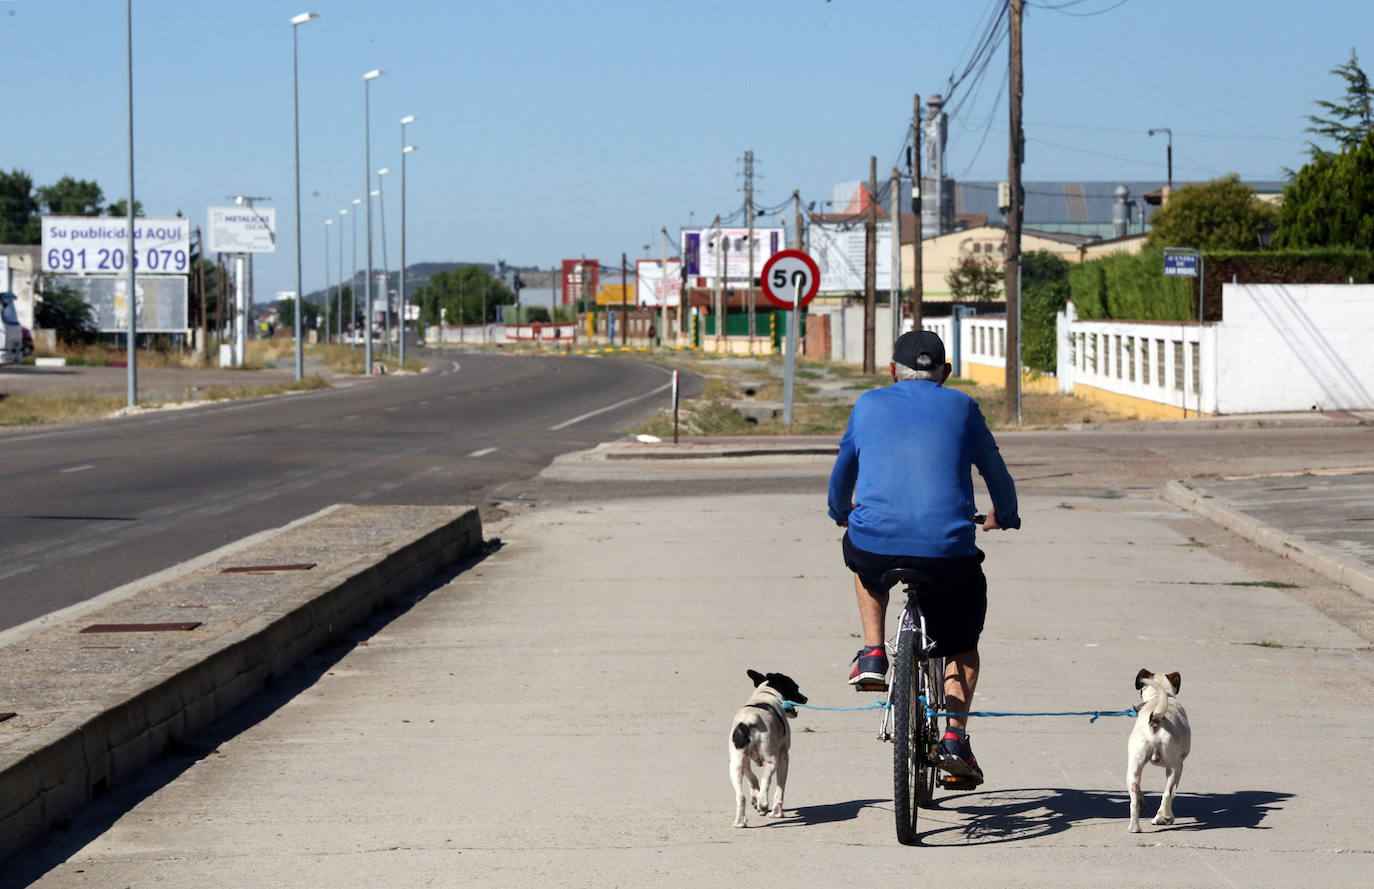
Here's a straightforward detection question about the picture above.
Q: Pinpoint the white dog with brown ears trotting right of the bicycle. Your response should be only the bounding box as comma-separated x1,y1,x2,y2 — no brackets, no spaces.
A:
1125,668,1193,834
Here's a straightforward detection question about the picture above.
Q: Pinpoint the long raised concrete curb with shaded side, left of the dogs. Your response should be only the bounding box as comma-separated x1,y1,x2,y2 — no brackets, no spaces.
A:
0,507,482,860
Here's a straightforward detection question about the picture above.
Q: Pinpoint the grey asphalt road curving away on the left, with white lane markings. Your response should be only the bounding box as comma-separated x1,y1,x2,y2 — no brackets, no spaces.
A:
0,353,688,629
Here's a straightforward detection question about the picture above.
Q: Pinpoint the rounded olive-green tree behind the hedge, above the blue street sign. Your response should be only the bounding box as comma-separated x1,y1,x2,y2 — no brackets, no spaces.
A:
1145,173,1279,250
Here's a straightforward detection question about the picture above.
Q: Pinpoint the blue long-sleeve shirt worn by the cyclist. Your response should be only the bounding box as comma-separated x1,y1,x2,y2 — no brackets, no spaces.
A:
829,379,1018,558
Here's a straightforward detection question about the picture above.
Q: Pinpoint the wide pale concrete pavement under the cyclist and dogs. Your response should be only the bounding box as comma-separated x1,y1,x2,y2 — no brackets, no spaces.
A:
7,486,1374,889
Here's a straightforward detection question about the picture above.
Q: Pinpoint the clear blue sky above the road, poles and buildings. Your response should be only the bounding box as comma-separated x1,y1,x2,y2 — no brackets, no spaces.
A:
0,0,1374,302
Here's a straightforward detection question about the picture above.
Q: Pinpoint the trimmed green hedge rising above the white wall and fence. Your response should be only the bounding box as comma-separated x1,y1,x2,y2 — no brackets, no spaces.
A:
1069,249,1374,322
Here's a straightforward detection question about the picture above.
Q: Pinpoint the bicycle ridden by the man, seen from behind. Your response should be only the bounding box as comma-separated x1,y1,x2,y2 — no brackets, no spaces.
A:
878,515,1020,845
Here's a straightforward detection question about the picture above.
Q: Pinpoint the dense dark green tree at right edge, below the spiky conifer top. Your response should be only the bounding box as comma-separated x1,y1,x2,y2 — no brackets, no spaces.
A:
1274,131,1374,250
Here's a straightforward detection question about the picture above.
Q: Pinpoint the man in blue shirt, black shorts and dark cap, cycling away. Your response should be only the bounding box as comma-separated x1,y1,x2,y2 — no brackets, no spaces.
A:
829,330,1021,785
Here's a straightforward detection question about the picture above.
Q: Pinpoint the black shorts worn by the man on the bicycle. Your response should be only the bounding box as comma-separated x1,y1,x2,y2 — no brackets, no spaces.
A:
842,533,988,655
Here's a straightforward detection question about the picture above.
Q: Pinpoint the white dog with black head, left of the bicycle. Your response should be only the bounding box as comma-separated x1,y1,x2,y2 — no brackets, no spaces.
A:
730,671,807,827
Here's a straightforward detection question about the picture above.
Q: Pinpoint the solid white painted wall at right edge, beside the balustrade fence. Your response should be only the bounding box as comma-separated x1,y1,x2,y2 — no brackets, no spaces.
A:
1215,284,1374,414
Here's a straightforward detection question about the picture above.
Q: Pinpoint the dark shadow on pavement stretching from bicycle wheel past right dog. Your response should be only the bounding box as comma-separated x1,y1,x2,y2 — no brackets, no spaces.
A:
918,787,1293,845
